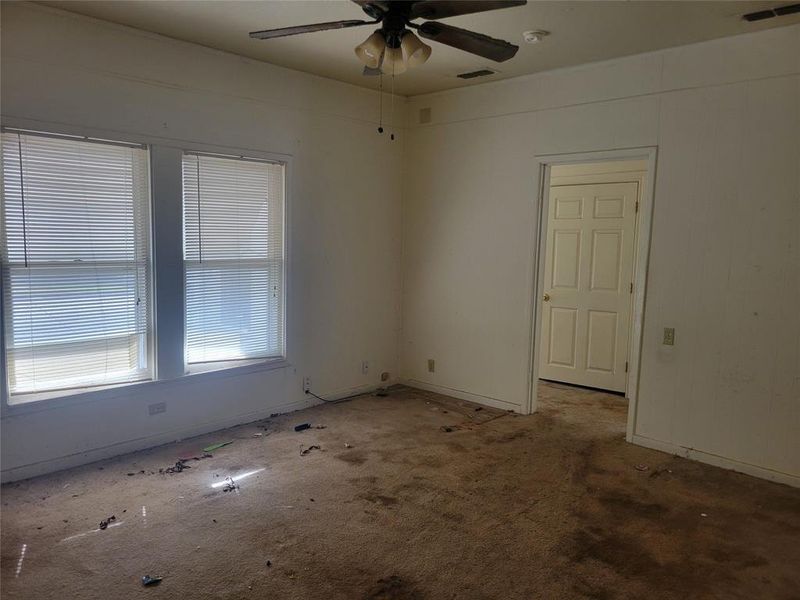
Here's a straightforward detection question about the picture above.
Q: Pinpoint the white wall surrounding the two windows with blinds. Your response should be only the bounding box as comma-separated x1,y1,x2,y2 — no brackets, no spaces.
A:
2,2,403,479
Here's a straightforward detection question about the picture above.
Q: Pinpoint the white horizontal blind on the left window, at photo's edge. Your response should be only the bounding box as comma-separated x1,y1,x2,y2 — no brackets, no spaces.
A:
2,131,151,403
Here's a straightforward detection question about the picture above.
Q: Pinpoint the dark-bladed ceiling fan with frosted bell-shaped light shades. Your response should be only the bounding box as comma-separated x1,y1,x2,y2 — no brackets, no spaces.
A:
250,0,527,75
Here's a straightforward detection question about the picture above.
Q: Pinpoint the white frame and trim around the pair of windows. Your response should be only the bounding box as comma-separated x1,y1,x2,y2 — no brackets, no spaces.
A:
0,116,294,418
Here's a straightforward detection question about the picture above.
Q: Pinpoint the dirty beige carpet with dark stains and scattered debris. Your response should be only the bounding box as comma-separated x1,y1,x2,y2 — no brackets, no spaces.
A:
0,384,800,600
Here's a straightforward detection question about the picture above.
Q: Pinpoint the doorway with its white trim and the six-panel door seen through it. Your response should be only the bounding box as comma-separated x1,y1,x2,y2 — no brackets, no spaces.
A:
530,148,655,440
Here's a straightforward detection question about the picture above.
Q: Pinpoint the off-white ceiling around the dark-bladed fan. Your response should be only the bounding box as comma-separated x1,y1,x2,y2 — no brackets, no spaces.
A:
36,0,800,96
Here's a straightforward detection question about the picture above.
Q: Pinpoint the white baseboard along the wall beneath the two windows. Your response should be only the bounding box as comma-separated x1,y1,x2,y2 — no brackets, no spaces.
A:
0,384,388,483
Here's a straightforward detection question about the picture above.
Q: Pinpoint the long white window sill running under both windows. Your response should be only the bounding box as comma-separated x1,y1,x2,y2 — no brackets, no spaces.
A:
2,357,289,418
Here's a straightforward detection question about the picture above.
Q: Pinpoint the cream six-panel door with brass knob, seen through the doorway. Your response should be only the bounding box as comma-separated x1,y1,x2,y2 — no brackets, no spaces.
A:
539,183,638,392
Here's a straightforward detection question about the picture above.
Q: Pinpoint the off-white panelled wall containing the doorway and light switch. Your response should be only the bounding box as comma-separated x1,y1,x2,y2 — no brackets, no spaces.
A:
401,26,800,485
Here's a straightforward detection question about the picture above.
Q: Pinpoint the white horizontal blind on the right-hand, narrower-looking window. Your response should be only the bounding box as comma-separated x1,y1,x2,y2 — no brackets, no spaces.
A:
183,154,284,364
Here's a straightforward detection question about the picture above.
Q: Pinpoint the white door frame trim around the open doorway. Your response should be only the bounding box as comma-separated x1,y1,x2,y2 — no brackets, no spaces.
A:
524,146,658,441
